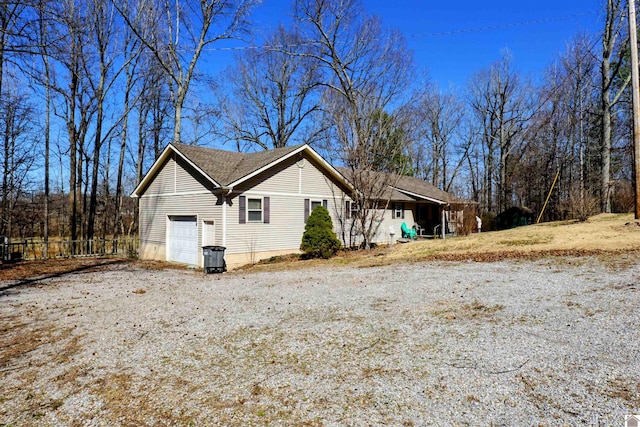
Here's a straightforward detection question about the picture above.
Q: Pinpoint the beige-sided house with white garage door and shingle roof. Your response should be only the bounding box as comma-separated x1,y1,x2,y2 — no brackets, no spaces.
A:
132,144,468,268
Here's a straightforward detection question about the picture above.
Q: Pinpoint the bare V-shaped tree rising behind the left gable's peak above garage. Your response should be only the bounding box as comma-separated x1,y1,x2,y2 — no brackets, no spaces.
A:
116,0,257,142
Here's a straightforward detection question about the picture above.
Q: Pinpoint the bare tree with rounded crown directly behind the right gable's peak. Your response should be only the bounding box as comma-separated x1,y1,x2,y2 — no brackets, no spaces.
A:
219,26,320,150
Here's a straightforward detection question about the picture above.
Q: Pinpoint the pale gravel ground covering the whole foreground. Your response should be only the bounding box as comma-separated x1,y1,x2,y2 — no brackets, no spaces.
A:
0,255,640,426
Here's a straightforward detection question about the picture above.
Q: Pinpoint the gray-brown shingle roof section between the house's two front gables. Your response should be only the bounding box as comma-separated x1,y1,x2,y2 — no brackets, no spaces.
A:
173,144,302,186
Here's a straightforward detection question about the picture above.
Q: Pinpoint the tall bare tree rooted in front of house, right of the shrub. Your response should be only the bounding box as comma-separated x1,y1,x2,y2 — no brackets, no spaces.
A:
294,0,412,248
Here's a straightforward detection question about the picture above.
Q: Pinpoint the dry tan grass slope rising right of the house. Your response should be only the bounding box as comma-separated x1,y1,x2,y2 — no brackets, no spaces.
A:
242,214,640,271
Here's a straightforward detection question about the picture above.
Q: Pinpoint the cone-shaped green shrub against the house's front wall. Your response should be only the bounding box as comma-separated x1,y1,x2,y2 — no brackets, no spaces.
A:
300,206,341,259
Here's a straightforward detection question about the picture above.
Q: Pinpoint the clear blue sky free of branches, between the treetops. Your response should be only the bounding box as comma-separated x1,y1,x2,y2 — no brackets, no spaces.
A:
207,0,603,89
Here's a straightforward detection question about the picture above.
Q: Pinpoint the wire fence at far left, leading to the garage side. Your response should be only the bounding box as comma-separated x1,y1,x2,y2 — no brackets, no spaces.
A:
0,237,138,261
